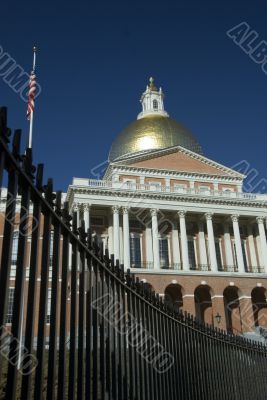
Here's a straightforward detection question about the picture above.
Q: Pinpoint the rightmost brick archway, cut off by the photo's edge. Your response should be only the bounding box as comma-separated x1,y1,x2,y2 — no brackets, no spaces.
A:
251,287,267,329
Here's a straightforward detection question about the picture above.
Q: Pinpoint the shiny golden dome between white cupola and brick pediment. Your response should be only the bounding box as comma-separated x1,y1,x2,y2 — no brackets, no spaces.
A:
109,115,202,161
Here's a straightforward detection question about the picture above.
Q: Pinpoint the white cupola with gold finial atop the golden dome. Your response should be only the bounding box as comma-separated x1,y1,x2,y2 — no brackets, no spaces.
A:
137,78,169,119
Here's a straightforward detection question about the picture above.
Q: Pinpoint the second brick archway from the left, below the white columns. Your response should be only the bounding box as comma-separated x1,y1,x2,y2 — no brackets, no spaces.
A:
194,285,213,325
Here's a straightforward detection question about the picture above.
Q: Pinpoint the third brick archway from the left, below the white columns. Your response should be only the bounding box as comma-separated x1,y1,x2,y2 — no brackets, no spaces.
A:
223,286,242,334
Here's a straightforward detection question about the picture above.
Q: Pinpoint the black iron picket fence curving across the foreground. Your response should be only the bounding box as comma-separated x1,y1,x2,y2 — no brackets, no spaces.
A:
0,109,267,400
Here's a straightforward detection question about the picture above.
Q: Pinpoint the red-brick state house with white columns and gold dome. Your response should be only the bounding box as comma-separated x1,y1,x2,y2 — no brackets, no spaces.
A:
1,78,267,334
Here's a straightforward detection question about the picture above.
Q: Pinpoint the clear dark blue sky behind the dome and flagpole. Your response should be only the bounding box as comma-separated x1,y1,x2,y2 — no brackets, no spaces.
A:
0,0,267,190
